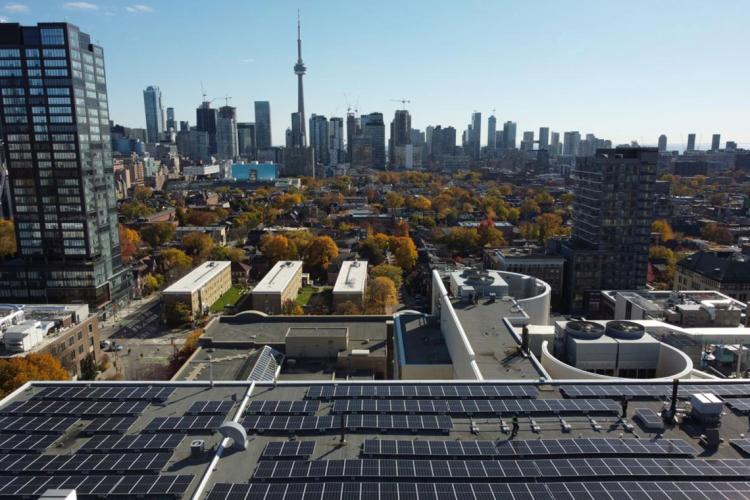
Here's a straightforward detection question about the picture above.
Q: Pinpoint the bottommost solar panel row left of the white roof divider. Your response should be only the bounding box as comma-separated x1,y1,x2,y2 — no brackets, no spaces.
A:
0,475,193,498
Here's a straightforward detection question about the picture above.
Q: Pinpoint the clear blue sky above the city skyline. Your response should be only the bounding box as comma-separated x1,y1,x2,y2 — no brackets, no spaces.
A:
5,0,750,148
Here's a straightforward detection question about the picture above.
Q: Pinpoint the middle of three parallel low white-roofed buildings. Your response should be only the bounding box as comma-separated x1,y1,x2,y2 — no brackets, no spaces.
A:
252,260,302,314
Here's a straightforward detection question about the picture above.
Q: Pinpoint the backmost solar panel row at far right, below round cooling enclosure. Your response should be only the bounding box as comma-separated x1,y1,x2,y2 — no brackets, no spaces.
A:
560,384,750,399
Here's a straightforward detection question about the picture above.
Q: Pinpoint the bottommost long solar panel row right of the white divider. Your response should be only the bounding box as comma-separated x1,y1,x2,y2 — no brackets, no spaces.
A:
206,481,750,500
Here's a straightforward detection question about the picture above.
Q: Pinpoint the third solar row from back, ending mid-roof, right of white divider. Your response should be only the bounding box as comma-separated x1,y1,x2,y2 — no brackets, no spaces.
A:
243,415,453,434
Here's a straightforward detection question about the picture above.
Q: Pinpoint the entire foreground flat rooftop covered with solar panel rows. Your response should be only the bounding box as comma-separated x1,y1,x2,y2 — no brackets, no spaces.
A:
0,380,750,500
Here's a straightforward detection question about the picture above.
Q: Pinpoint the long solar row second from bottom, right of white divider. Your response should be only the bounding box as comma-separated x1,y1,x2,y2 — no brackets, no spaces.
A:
253,458,750,482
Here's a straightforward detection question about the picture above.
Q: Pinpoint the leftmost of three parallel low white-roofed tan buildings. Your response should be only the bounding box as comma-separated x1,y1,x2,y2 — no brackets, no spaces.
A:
162,260,232,314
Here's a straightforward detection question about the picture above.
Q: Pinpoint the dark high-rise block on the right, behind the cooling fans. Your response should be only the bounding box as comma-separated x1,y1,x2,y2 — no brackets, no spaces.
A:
563,148,658,312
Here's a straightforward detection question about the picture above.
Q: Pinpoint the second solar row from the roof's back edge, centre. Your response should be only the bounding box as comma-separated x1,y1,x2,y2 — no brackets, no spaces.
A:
331,399,622,416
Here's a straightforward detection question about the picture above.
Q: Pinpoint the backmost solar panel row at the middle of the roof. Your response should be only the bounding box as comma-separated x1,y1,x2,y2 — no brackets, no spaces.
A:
305,384,539,399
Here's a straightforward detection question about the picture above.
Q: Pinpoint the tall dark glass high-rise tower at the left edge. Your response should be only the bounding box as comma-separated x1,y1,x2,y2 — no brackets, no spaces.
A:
0,23,130,310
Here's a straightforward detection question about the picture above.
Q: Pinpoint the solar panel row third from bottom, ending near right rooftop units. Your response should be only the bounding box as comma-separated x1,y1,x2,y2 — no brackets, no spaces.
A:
362,438,695,459
